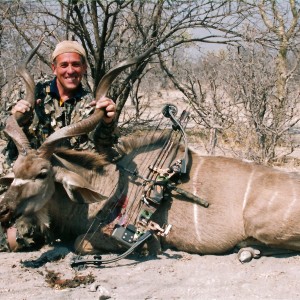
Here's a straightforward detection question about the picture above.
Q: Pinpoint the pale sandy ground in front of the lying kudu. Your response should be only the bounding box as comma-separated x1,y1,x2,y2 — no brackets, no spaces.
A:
0,247,300,300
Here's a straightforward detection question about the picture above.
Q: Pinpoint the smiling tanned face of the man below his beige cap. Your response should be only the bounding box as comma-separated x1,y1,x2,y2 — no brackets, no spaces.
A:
52,53,87,92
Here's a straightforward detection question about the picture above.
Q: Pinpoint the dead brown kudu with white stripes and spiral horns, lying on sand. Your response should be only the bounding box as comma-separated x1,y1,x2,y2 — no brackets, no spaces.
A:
0,45,300,261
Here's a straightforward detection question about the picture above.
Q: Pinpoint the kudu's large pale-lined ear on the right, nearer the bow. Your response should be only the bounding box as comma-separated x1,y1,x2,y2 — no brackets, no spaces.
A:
54,167,107,204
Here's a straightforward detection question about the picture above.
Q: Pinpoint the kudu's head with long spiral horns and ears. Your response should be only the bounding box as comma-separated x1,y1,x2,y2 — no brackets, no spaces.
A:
0,45,153,223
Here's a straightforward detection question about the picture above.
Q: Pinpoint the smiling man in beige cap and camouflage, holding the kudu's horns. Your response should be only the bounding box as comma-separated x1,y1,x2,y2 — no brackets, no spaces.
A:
0,41,116,251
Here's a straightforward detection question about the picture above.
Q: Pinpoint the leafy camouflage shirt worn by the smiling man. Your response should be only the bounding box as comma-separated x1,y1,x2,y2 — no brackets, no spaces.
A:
6,78,117,162
